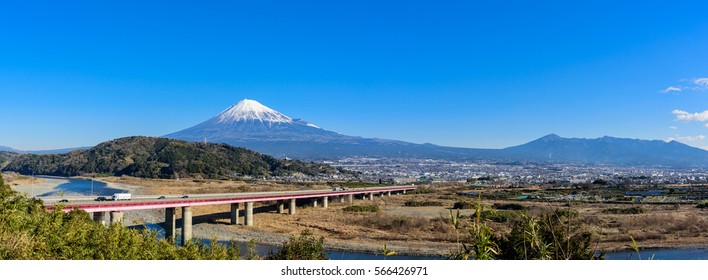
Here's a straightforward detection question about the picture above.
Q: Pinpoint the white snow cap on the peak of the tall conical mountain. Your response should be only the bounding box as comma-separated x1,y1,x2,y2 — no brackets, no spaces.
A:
216,99,293,124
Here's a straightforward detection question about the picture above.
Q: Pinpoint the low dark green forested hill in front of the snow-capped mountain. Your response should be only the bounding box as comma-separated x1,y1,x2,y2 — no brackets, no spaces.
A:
3,137,338,179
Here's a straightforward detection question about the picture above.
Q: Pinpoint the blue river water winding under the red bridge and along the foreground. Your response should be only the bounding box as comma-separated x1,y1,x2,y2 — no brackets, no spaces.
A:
42,176,708,260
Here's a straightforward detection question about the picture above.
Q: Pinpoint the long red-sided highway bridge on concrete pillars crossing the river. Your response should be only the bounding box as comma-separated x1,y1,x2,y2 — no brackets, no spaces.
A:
42,186,416,244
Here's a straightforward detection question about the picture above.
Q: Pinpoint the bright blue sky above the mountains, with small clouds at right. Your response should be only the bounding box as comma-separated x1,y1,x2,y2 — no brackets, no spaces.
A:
0,0,708,149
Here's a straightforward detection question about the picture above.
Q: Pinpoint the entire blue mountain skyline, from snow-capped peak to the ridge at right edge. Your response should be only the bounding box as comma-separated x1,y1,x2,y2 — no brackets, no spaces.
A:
165,100,708,168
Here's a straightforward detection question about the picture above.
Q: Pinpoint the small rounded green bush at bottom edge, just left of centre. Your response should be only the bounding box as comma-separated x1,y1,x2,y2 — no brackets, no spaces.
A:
268,230,327,260
